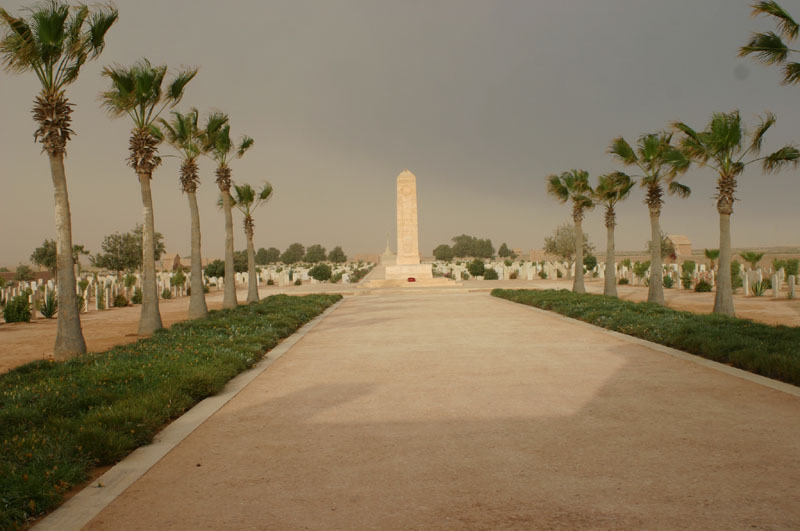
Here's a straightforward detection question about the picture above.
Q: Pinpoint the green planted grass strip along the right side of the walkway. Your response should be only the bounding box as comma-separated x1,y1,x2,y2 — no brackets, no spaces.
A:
492,289,800,385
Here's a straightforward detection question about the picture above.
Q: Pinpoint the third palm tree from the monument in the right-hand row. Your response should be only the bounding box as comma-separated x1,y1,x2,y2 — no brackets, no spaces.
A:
608,132,691,305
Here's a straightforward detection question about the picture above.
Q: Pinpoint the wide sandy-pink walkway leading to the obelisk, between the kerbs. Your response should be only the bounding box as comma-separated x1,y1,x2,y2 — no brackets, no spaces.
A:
64,292,800,530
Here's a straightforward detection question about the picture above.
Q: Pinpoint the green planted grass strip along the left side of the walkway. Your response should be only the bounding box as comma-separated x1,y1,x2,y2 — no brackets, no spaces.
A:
0,295,341,529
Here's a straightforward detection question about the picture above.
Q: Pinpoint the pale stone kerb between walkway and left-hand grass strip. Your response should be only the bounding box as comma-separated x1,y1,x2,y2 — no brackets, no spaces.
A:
32,299,344,531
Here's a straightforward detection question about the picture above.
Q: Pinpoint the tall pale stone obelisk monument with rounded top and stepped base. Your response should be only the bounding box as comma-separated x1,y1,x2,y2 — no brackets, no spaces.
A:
386,170,433,280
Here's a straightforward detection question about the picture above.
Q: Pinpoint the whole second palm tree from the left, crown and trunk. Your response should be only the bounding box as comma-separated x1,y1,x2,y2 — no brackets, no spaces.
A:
101,59,197,335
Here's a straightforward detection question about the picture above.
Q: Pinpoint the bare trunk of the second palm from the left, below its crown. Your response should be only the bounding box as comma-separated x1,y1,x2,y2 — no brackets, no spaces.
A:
139,172,164,336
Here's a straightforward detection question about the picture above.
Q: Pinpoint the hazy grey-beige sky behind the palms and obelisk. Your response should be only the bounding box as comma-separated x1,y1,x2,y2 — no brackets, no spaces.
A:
0,0,800,266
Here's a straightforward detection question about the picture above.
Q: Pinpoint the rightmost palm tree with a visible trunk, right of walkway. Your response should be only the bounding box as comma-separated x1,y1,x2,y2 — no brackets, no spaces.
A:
673,111,800,315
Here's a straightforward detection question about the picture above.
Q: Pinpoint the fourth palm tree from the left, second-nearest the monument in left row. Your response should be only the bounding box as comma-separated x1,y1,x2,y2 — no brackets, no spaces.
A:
203,113,253,308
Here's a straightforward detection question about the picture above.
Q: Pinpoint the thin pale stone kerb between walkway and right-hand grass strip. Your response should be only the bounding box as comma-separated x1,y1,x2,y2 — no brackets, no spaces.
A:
492,297,800,398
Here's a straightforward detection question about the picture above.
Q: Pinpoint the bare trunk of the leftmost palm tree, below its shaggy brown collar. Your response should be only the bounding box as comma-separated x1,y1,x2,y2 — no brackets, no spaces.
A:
49,153,86,360
